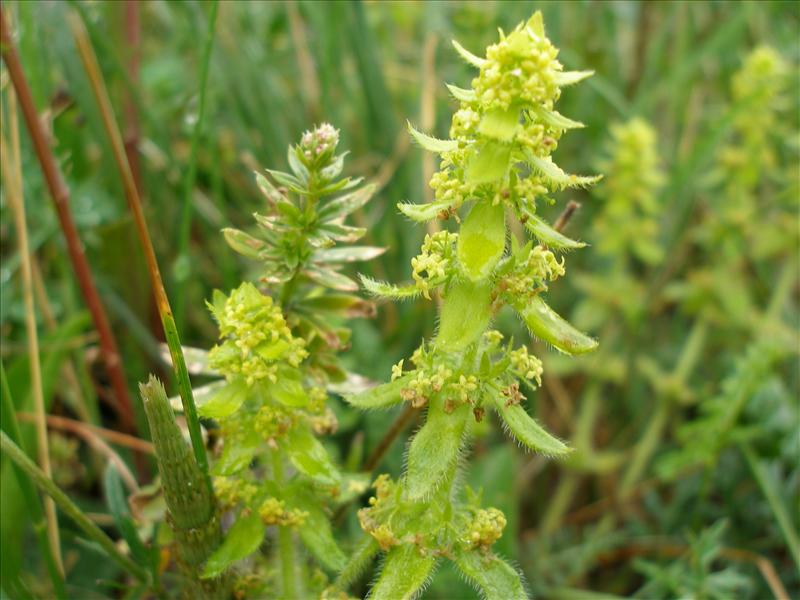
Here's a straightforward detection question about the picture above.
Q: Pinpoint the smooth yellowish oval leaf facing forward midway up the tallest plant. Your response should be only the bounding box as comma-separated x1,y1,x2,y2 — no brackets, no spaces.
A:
456,200,506,281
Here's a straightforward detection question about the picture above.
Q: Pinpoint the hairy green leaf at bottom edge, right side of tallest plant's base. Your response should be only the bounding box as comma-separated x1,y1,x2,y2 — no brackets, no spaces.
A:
453,548,528,600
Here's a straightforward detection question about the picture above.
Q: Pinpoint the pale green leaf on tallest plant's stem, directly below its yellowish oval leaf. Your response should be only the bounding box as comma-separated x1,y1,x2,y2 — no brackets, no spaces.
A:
436,281,492,350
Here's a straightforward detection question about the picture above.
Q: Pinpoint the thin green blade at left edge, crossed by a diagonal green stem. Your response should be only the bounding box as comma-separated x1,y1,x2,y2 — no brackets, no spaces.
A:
0,361,67,599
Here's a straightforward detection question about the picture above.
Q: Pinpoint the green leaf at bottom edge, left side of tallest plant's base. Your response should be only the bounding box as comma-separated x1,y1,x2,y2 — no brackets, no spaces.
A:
369,544,436,600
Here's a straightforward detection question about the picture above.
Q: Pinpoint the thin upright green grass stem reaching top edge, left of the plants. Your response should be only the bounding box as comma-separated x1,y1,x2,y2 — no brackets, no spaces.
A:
175,0,219,327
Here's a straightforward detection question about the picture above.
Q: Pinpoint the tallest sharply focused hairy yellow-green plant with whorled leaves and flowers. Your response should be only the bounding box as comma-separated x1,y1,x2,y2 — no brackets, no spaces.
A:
337,12,598,599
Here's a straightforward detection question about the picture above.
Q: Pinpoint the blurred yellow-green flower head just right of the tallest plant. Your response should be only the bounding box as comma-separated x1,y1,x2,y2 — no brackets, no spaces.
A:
597,118,664,263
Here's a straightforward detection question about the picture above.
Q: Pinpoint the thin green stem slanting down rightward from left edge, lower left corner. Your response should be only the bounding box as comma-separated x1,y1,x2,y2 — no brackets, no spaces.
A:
0,431,150,583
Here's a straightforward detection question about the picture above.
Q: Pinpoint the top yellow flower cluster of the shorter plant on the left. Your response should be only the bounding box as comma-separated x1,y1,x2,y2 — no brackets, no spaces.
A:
209,283,308,385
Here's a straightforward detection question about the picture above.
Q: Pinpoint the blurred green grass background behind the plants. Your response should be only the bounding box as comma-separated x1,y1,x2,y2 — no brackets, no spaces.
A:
0,1,800,598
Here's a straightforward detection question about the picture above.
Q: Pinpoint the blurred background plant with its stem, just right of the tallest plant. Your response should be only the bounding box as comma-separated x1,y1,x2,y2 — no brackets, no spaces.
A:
541,117,665,534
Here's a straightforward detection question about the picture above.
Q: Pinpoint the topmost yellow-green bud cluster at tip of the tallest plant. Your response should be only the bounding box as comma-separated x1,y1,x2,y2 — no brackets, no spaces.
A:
472,13,562,110
